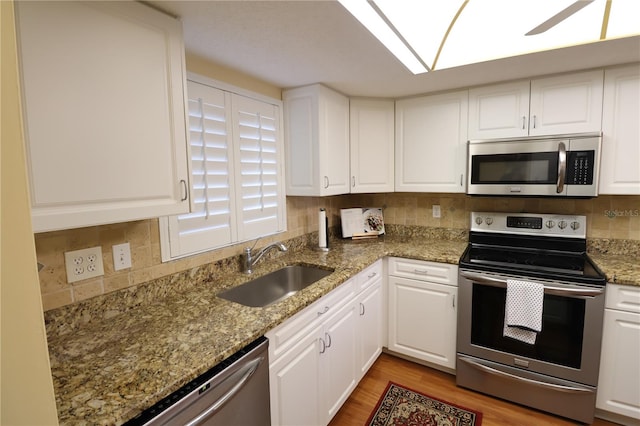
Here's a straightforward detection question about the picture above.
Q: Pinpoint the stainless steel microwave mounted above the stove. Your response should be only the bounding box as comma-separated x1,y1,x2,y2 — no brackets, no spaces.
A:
467,134,602,198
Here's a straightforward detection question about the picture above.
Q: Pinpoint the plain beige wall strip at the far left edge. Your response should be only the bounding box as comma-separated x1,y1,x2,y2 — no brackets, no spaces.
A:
0,1,58,425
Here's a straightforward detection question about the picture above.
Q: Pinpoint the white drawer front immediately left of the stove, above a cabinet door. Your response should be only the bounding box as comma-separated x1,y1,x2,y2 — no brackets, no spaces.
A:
389,257,458,286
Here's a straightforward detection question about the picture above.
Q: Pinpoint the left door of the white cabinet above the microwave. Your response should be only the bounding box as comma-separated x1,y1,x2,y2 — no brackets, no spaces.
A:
469,80,530,140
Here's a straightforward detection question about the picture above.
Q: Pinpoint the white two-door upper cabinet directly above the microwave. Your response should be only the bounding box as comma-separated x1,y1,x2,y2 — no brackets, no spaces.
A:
469,70,603,140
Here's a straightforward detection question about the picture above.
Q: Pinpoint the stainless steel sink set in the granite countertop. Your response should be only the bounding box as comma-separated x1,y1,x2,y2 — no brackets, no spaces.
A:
218,265,333,308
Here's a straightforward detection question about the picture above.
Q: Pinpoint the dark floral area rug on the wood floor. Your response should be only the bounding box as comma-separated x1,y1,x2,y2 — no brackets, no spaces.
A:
367,382,482,426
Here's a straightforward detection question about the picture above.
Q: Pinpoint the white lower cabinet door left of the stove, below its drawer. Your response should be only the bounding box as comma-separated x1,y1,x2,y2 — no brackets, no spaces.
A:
389,276,458,369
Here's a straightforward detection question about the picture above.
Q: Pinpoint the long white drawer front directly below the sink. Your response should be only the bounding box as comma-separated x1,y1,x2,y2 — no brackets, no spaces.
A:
266,279,354,361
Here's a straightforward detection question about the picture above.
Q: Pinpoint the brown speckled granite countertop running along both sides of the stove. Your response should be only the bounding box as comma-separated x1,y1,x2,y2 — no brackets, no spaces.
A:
45,236,640,425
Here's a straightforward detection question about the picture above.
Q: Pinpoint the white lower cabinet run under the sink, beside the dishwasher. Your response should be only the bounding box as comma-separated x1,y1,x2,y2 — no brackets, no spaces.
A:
266,261,383,426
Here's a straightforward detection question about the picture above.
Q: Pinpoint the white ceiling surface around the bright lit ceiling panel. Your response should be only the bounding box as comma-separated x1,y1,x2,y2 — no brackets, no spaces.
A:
148,0,640,98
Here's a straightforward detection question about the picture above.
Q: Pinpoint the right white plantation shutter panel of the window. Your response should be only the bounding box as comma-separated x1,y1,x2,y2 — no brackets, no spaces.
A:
232,95,285,240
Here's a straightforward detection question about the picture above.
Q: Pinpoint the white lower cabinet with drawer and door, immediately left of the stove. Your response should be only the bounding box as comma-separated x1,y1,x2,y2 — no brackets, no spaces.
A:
388,258,458,370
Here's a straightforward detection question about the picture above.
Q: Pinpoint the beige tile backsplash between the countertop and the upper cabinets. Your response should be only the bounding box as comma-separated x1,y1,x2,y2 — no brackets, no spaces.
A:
35,193,640,310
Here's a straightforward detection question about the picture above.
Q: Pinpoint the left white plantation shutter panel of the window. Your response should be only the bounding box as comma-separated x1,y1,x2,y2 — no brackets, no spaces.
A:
169,81,237,258
